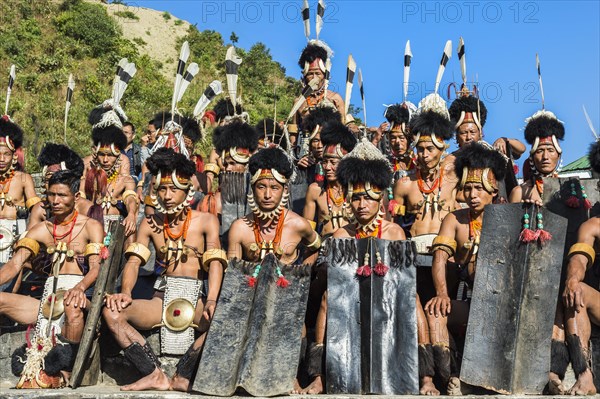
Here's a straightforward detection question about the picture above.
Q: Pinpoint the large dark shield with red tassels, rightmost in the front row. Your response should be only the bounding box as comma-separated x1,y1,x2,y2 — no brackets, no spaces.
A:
460,204,567,394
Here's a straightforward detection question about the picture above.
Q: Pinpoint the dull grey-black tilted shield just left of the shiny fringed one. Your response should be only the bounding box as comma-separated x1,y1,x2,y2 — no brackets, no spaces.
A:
193,255,310,396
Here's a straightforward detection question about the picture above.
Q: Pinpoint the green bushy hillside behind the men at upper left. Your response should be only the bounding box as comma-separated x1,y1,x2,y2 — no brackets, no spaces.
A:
0,0,300,171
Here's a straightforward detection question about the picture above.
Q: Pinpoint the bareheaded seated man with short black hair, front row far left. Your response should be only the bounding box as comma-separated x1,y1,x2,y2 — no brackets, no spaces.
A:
0,170,104,388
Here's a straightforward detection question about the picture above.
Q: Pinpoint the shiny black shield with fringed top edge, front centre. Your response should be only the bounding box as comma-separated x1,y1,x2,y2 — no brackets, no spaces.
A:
323,239,419,395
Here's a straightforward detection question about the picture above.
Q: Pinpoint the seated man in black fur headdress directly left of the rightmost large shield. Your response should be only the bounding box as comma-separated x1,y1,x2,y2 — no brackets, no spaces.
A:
425,143,506,395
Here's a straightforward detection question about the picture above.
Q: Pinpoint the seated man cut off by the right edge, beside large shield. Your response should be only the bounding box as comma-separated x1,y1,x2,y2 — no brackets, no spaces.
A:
550,141,600,395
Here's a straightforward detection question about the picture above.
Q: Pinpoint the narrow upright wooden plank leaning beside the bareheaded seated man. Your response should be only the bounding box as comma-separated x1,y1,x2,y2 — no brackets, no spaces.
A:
69,221,125,388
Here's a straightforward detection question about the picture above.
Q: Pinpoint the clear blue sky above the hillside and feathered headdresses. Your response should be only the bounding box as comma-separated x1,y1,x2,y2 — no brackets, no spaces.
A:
127,0,600,165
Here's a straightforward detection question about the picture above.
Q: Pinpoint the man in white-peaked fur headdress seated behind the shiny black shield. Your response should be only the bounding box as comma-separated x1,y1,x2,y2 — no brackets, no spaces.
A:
332,139,439,395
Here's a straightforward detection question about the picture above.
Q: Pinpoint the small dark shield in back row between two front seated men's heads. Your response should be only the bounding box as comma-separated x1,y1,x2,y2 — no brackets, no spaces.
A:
219,172,250,248
